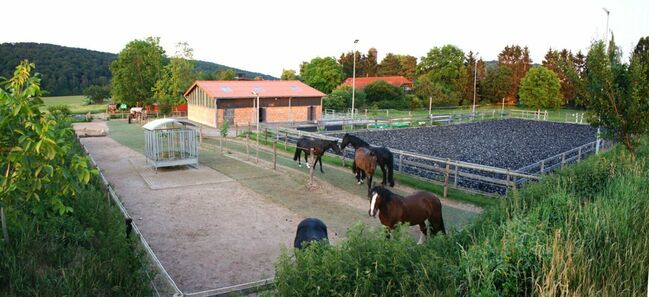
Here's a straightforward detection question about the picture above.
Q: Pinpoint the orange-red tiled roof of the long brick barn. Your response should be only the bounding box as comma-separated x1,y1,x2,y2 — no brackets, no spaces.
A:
185,80,325,99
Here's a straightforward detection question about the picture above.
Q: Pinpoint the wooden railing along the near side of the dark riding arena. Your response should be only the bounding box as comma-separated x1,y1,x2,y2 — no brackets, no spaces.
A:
260,125,538,195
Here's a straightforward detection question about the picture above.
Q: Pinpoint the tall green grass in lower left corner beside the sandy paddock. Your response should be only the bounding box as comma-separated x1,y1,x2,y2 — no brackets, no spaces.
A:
0,140,152,296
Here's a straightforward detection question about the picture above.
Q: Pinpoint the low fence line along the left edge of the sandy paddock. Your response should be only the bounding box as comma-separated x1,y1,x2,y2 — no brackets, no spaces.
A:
77,138,183,297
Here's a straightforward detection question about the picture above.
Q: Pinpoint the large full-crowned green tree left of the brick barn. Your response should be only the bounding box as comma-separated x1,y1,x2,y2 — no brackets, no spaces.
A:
110,37,165,105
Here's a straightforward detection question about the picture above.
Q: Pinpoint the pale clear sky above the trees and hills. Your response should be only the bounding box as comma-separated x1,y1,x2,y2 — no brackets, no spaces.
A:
0,0,649,77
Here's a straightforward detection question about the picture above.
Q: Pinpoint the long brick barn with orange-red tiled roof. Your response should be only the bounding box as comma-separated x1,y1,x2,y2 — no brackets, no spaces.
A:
185,80,325,127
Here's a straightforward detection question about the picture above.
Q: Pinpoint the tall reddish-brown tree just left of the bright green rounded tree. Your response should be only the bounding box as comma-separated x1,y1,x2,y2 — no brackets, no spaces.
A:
498,45,532,102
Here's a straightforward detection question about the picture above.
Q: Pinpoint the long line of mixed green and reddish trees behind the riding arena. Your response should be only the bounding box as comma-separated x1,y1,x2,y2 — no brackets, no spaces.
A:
292,38,646,118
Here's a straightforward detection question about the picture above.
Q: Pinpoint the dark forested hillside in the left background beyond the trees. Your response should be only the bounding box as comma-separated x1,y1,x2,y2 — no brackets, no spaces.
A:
0,42,275,96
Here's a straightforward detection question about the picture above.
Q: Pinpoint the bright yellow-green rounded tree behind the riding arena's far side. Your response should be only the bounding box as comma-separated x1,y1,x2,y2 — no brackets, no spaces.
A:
518,66,563,110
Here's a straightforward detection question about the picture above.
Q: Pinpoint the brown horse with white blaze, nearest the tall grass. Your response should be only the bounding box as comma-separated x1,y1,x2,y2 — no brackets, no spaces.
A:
369,186,446,244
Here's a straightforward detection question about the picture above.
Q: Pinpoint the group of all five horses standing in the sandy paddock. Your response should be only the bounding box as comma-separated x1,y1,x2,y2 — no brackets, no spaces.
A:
293,133,446,249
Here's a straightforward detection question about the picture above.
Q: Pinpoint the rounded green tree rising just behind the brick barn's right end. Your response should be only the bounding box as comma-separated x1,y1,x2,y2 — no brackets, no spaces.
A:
300,57,344,94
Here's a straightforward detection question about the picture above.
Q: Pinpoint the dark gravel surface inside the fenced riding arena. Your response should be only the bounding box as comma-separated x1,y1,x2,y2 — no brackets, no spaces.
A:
342,119,596,169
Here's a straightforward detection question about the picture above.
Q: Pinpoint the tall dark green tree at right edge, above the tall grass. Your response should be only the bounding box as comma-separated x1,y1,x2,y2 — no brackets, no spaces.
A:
586,39,649,156
